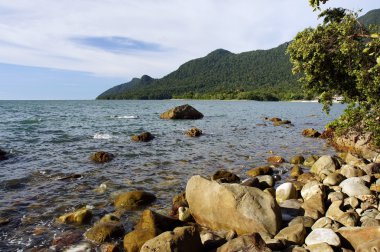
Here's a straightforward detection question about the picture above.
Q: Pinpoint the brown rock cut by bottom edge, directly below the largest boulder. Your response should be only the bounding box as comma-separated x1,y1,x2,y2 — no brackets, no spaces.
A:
216,233,272,252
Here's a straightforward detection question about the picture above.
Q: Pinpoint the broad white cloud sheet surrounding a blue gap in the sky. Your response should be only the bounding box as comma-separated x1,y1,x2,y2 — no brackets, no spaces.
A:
0,0,378,79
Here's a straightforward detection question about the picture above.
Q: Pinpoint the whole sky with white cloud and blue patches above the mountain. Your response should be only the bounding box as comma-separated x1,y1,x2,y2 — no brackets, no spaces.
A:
0,0,380,100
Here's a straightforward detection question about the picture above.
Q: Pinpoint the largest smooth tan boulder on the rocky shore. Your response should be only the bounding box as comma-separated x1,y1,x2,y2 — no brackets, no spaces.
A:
186,175,281,236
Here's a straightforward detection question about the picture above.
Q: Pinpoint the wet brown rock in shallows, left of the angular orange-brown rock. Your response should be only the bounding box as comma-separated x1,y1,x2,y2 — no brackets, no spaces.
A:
84,221,124,244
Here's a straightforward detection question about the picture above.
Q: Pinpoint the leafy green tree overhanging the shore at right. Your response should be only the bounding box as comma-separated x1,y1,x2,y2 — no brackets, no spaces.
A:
287,3,380,146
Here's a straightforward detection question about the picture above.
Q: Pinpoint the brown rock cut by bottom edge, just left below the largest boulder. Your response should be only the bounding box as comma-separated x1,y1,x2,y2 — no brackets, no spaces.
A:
140,227,203,252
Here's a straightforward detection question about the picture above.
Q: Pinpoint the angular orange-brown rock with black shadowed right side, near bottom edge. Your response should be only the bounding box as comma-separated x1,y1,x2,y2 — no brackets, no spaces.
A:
124,210,182,252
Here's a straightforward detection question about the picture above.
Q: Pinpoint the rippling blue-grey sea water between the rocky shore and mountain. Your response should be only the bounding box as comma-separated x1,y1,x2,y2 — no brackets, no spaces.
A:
0,100,344,251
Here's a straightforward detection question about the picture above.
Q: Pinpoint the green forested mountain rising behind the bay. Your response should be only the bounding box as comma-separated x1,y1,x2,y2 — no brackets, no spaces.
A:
97,9,380,100
